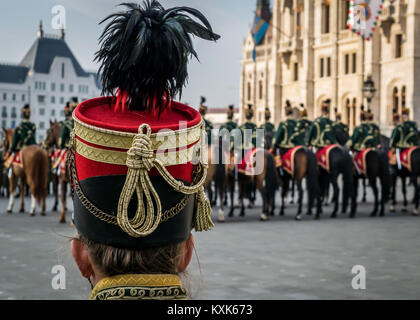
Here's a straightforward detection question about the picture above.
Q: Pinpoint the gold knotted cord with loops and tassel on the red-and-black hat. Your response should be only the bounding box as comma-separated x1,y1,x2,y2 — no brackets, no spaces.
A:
68,124,214,238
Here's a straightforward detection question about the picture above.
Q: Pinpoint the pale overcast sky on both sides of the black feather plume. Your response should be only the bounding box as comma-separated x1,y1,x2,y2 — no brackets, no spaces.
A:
0,0,257,107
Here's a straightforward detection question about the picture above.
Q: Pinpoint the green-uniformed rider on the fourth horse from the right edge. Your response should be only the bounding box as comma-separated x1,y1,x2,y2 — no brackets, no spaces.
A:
273,100,304,154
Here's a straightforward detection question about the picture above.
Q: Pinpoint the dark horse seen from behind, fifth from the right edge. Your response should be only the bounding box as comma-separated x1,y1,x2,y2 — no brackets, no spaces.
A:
227,148,280,221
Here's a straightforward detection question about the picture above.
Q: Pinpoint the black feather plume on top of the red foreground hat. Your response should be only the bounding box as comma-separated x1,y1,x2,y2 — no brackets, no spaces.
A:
95,0,220,114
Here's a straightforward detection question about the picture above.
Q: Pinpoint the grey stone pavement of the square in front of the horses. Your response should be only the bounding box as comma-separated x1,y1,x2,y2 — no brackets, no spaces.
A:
0,185,420,299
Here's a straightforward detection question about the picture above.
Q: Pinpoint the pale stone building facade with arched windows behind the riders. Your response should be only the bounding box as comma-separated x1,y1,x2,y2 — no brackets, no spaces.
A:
240,0,420,134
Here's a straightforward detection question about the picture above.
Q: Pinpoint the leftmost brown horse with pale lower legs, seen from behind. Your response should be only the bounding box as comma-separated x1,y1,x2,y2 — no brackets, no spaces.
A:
3,128,48,216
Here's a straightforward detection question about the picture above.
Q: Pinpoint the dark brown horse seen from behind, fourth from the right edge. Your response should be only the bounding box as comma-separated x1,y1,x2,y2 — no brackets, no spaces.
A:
279,147,322,221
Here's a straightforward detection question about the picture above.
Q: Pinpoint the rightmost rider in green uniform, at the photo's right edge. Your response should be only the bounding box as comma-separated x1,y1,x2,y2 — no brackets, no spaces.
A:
390,108,420,149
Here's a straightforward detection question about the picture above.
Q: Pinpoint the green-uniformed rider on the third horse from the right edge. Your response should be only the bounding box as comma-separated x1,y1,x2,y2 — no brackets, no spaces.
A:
306,100,337,149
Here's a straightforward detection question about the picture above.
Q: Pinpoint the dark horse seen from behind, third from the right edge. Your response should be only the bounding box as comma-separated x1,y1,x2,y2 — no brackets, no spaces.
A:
319,146,356,218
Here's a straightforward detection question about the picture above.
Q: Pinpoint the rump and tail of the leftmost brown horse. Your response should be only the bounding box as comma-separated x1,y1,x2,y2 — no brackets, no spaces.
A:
22,146,48,203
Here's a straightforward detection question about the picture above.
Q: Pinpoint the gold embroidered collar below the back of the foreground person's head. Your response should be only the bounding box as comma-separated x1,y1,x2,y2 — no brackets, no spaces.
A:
90,274,187,300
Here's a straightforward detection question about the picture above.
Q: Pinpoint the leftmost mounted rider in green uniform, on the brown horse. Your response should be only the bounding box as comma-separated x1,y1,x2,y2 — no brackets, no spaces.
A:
10,104,36,153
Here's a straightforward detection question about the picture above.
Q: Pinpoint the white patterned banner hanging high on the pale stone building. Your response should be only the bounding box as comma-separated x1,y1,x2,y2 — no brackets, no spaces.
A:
347,0,384,40
